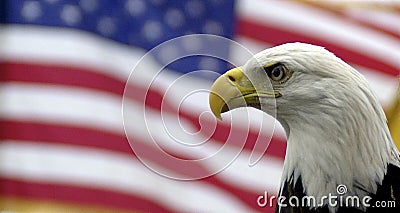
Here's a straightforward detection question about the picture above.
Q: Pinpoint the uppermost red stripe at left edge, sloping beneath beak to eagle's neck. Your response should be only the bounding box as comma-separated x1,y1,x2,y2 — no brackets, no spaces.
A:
0,62,286,159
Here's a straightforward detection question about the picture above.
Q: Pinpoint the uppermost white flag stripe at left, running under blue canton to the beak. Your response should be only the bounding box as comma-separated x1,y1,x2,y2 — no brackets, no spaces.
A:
0,25,222,92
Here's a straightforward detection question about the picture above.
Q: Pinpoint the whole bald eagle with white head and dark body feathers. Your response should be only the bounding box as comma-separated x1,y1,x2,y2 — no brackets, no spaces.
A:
209,43,400,213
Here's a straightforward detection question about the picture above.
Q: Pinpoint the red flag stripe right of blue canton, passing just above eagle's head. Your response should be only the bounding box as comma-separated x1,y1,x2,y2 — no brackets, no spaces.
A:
236,17,400,76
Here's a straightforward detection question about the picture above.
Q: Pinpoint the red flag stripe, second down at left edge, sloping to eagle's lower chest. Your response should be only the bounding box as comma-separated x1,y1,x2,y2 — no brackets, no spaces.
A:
0,121,280,210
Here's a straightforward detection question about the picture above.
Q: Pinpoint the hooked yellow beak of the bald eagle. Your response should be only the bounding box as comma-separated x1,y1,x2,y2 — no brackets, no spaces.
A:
209,67,260,119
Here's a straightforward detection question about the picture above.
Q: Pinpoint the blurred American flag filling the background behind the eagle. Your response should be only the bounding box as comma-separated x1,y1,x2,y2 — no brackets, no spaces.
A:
0,0,400,212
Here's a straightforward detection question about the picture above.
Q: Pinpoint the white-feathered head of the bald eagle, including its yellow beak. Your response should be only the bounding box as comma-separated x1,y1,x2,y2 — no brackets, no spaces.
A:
209,43,382,133
